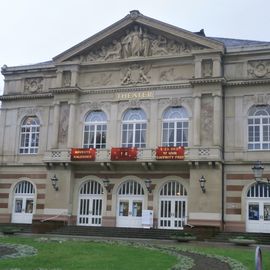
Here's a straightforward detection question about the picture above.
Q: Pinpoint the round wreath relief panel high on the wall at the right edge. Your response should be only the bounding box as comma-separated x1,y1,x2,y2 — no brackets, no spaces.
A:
247,61,270,79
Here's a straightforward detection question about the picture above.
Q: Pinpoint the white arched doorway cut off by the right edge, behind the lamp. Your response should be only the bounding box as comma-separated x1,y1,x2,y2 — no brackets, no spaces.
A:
246,183,270,233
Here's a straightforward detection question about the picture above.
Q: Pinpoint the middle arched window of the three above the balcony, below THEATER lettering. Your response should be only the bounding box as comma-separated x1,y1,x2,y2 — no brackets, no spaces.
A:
122,109,146,148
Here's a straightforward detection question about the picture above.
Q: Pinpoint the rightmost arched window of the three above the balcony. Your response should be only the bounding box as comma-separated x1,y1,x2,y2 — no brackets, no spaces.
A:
162,107,188,146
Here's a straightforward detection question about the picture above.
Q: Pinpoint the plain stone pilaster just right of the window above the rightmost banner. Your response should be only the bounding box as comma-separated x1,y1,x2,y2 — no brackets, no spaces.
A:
193,95,201,146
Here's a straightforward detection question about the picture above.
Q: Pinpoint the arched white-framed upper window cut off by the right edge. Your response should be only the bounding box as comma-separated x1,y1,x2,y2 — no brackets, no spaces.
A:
248,105,270,150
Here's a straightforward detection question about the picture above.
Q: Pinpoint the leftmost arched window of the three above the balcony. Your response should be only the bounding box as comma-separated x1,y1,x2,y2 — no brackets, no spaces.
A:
83,111,107,148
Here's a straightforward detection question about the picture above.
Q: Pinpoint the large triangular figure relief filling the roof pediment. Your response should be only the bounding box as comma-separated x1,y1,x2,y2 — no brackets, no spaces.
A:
76,25,205,62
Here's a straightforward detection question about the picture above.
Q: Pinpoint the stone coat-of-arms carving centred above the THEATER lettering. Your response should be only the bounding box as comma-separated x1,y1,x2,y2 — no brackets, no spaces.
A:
121,64,151,85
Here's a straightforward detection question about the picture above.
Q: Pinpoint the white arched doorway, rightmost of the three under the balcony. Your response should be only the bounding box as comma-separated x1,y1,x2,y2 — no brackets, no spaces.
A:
158,181,187,229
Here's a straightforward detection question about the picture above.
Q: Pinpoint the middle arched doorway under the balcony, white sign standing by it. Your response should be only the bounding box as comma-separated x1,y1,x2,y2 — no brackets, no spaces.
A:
116,180,144,228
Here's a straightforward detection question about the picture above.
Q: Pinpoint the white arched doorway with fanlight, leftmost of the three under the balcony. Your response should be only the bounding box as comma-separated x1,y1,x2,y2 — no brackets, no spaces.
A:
77,180,103,226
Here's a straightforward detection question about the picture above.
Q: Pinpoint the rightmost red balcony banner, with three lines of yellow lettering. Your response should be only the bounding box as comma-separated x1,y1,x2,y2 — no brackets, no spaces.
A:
156,146,185,160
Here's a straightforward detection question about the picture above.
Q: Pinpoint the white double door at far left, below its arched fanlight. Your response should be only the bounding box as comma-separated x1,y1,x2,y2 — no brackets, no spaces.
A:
12,195,34,224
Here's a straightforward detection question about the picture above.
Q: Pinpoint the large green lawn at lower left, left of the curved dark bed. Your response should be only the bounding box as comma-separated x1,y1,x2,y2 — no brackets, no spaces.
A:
0,236,177,270
